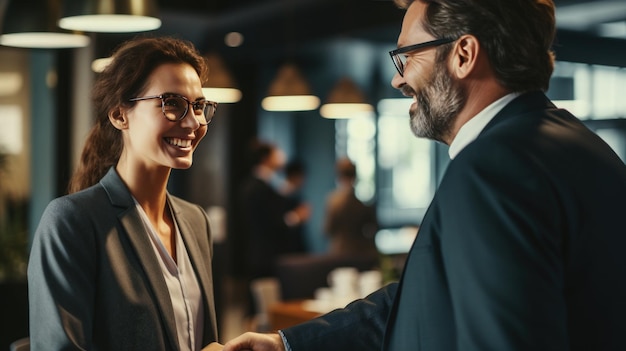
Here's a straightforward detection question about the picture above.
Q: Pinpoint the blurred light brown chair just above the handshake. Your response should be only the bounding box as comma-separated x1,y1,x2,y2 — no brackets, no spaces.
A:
250,277,281,332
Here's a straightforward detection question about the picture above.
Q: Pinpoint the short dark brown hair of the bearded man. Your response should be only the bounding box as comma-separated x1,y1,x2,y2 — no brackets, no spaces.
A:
395,0,556,92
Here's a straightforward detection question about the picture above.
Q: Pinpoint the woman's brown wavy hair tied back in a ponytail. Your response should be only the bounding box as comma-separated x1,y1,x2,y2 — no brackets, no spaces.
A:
68,37,208,193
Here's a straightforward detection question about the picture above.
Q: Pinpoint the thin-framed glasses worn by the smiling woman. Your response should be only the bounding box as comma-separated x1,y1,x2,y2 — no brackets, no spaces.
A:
129,93,217,125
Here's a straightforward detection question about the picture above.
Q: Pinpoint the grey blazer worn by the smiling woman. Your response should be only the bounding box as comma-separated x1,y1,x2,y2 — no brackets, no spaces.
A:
28,168,217,350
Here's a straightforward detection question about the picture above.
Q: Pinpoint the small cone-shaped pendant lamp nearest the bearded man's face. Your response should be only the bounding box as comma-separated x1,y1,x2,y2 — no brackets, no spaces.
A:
320,77,374,118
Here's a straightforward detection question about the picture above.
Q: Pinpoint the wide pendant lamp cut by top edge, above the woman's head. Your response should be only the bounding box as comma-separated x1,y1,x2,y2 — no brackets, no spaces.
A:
59,0,161,33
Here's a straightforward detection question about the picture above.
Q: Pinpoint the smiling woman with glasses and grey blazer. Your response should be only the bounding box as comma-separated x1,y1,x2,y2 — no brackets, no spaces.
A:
28,38,217,350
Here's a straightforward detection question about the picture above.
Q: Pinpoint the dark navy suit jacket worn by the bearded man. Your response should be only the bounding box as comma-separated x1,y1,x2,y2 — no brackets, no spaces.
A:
283,92,626,351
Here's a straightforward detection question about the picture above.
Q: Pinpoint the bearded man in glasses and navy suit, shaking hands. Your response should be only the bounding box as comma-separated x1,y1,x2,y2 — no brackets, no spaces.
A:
224,0,626,351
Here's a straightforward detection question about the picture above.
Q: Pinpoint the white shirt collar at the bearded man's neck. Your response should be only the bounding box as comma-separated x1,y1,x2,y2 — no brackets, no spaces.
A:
448,93,520,160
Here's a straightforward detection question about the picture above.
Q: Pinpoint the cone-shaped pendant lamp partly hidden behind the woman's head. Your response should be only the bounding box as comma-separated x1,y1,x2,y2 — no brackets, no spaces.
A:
202,54,241,104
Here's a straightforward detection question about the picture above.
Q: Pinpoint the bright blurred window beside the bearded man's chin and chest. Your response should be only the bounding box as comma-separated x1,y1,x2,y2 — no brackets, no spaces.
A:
335,98,441,227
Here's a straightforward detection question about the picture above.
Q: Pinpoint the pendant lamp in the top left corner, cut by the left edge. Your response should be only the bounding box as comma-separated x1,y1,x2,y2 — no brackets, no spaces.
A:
0,0,89,49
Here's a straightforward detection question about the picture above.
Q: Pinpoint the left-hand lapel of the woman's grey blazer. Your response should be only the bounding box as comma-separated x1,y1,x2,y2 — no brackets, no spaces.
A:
100,168,178,350
